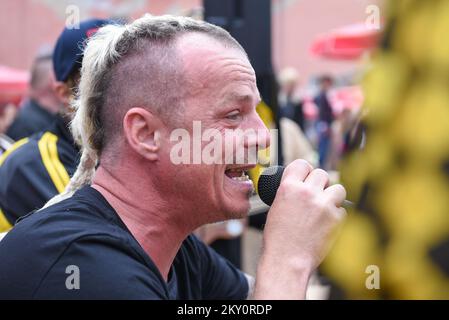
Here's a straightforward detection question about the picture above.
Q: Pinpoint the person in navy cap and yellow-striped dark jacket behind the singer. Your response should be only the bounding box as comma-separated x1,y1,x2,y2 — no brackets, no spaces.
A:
0,19,108,232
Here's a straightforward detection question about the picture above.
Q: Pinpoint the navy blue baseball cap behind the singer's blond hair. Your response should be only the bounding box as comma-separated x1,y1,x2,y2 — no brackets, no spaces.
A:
53,19,114,81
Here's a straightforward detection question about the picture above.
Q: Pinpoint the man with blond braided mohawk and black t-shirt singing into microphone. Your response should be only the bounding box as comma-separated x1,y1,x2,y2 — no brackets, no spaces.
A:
0,16,346,299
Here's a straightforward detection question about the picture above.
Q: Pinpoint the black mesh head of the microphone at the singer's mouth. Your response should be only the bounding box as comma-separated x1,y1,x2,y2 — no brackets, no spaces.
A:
257,166,285,206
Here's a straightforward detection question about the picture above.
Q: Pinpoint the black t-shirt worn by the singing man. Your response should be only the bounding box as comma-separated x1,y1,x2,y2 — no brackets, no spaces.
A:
0,187,248,299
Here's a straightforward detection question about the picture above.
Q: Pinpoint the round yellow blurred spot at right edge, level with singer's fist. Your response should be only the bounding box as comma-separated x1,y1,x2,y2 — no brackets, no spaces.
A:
375,167,449,244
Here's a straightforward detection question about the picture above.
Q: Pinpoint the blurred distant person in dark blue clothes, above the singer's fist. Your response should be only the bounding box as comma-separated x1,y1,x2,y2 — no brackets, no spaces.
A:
314,75,334,168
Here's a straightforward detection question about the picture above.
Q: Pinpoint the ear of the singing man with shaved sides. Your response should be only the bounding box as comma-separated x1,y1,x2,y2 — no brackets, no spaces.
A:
123,107,162,161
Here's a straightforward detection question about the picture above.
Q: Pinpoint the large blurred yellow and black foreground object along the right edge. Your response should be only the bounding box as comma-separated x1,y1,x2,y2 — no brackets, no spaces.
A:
322,0,449,299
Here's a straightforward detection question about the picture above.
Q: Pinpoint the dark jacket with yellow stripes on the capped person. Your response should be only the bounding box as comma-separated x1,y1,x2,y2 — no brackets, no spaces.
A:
0,117,79,232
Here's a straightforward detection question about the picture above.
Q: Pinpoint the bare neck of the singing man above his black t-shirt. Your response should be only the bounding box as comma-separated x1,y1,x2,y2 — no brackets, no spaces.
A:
92,165,194,280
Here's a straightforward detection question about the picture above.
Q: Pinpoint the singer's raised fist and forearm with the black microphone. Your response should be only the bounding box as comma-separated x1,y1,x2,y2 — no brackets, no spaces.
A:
252,160,346,299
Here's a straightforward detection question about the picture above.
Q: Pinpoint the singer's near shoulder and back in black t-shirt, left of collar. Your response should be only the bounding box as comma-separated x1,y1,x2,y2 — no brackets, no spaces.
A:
0,192,163,299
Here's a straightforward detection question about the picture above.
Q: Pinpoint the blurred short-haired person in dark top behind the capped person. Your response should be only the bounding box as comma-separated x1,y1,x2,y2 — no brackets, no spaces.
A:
6,49,62,141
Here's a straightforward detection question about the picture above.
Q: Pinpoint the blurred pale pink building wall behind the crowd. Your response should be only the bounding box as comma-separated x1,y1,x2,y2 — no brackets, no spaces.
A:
0,0,381,79
